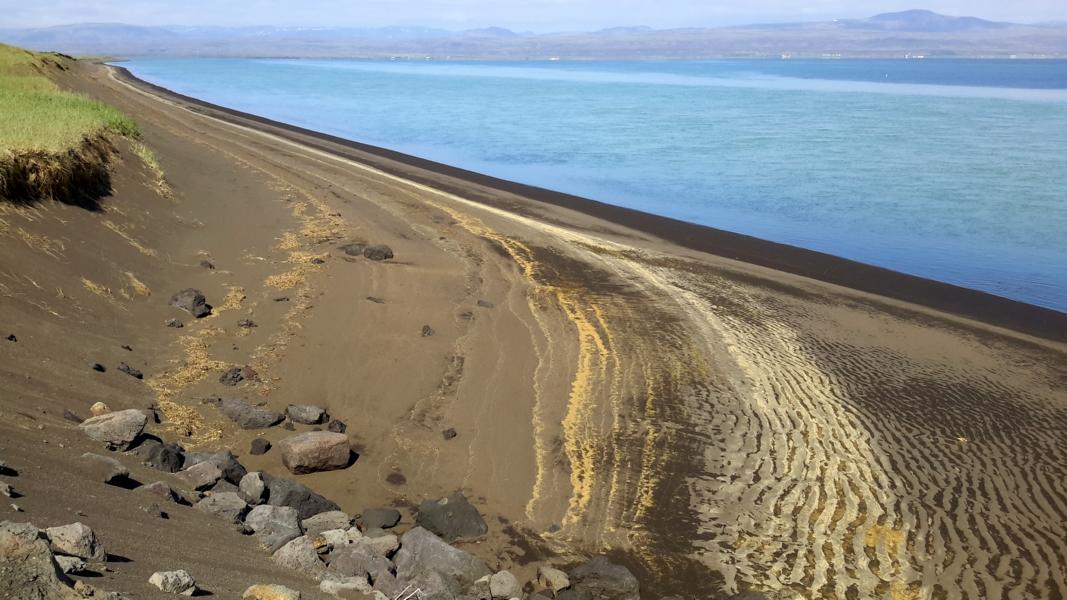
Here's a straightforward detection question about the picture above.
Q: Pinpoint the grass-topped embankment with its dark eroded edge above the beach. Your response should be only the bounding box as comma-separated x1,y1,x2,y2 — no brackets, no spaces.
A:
0,44,138,202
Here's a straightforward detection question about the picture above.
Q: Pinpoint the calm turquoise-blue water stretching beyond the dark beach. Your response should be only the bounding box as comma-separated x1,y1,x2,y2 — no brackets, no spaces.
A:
123,59,1067,312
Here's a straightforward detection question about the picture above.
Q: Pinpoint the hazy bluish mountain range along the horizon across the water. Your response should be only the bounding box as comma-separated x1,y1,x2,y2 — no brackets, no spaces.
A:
0,10,1067,60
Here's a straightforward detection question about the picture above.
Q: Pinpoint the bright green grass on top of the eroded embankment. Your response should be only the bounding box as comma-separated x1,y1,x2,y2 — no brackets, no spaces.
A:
0,44,138,154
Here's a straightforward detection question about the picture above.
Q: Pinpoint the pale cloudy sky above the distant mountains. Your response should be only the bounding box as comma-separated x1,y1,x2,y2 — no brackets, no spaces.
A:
0,0,1067,32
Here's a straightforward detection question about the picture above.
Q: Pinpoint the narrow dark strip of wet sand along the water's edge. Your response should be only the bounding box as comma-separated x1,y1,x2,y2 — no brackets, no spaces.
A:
108,65,1067,342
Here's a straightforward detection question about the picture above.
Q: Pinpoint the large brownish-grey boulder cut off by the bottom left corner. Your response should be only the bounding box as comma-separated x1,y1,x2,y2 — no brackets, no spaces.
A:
0,521,82,600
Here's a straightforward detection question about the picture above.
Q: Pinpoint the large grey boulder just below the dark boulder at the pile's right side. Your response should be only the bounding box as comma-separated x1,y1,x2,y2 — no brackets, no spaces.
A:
394,527,490,597
